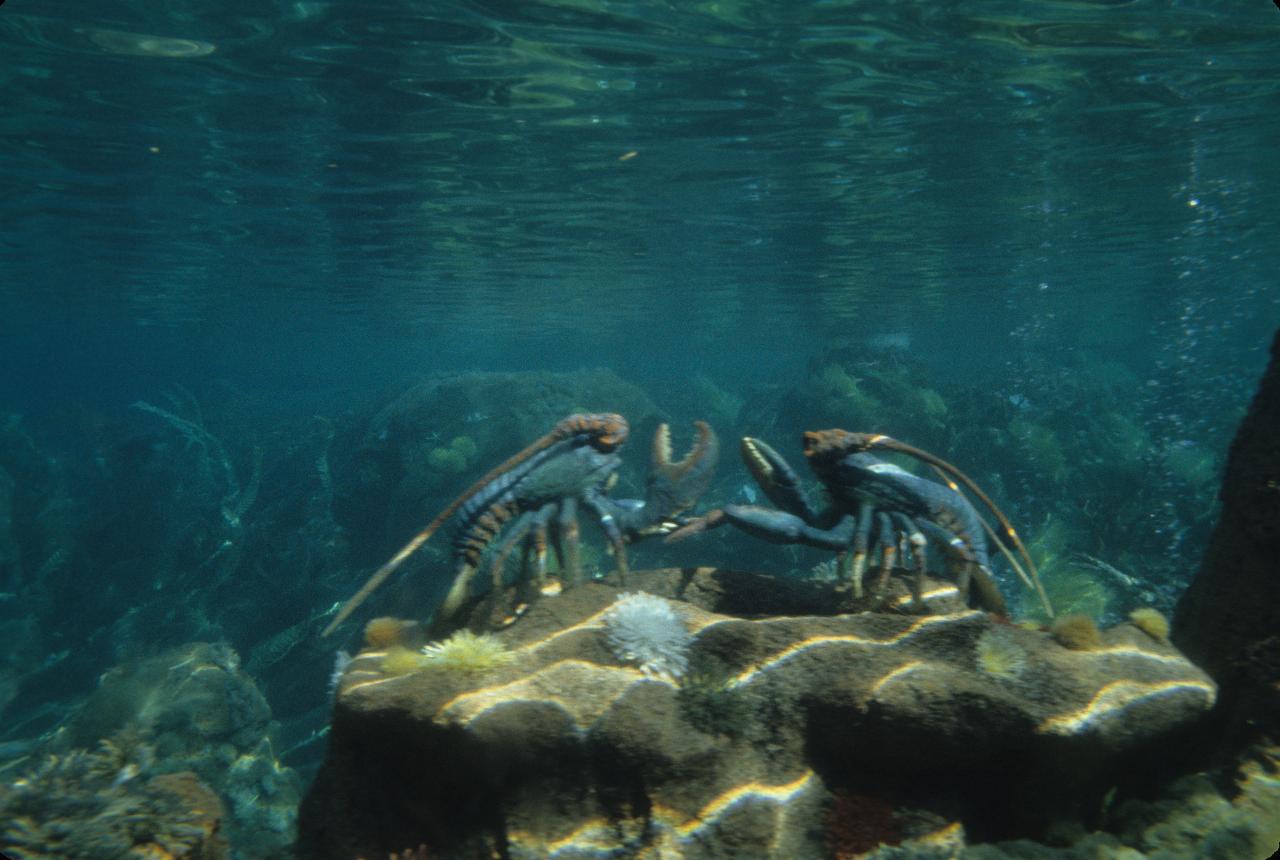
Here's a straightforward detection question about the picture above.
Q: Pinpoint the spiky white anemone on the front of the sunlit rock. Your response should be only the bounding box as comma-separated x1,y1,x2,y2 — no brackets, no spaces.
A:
604,591,692,681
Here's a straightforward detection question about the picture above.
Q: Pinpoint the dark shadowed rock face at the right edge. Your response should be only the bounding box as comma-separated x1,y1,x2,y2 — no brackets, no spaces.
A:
1172,333,1280,747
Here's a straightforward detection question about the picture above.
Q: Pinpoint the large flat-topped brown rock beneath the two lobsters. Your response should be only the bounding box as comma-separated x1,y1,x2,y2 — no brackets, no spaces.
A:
300,568,1216,859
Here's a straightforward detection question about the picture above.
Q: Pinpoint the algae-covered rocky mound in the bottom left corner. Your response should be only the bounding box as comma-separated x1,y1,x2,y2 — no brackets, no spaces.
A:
0,642,300,860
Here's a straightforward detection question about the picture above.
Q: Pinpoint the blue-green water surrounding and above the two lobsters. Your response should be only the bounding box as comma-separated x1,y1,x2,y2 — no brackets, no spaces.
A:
0,0,1280,854
